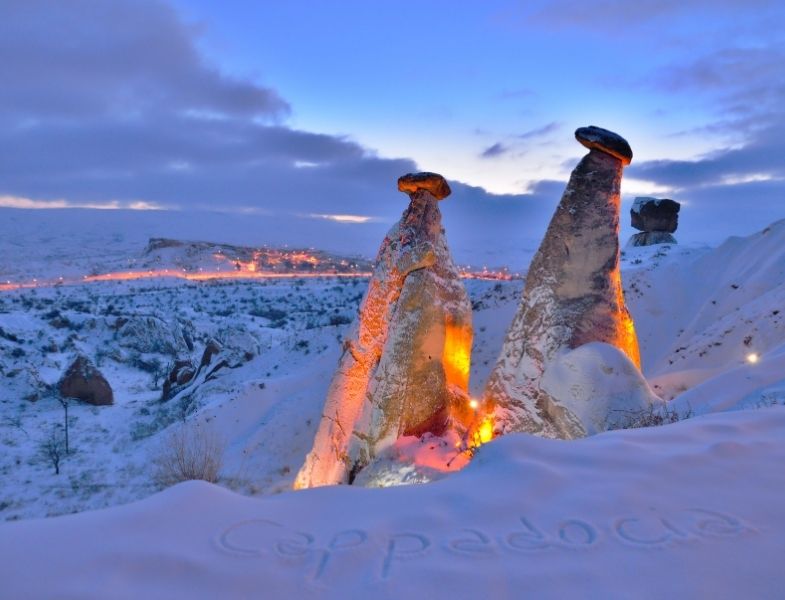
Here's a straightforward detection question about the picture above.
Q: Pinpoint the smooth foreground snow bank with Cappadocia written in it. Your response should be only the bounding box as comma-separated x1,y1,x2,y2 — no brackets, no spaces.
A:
0,407,785,600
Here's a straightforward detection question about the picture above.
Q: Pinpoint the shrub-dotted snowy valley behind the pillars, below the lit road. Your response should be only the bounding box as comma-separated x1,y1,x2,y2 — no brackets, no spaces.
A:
0,279,521,520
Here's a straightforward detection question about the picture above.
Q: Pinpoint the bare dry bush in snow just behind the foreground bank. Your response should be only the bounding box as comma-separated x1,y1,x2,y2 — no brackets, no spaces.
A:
153,425,226,487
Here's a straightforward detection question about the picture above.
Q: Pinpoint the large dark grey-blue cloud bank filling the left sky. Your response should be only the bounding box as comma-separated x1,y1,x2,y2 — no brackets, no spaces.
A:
0,0,558,264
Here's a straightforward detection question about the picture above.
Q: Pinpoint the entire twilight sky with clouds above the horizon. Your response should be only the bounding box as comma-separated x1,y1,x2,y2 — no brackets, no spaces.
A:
0,0,785,262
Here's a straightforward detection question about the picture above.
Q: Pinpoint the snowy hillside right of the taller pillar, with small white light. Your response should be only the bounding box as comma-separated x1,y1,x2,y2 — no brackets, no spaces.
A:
624,221,785,412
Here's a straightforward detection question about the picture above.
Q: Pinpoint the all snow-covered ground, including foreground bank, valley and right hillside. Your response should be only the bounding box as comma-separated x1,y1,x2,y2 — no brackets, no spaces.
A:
0,213,785,598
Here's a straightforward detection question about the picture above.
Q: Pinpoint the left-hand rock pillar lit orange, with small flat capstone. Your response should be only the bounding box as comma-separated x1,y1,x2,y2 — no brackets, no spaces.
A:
295,173,473,488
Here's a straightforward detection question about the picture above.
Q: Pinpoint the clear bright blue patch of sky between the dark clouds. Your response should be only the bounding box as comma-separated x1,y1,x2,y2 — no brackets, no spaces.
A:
167,2,728,193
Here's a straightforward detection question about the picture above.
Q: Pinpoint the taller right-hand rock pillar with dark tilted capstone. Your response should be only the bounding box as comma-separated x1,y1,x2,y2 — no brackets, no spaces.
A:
485,126,640,439
